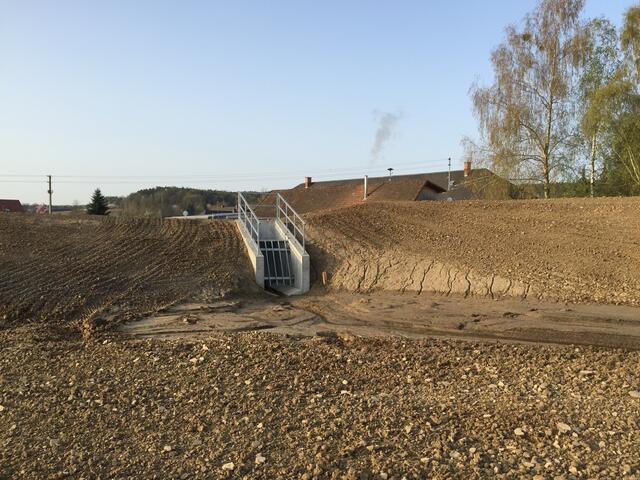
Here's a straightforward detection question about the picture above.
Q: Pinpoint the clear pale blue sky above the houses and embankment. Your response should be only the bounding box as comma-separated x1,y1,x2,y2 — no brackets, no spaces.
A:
0,0,632,204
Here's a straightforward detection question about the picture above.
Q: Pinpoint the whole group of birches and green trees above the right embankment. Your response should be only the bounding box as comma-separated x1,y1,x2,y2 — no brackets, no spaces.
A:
463,0,640,198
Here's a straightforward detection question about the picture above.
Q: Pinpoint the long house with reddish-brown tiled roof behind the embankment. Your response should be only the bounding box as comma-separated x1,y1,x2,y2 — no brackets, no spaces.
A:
256,164,509,216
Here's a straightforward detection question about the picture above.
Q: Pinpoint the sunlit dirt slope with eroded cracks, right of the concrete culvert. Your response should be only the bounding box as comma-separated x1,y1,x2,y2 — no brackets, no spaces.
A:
307,198,640,305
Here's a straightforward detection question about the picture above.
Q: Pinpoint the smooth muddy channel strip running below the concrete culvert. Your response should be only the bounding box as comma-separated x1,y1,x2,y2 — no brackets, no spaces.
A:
119,288,640,350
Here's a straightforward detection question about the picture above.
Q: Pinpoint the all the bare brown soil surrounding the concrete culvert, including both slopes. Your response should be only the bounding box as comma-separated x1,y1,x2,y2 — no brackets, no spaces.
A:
0,199,640,480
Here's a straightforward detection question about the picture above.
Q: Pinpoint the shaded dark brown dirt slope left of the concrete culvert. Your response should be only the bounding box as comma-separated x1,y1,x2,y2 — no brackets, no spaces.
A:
0,215,251,325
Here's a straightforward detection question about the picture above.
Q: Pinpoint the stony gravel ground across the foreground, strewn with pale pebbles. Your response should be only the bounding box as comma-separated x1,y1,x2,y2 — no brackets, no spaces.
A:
0,325,640,479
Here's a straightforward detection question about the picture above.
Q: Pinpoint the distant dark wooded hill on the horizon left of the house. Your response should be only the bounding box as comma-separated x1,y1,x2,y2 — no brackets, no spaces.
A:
109,187,262,217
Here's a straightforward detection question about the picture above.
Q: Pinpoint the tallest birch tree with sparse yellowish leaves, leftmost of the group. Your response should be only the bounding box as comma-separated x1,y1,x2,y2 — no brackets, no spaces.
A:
470,0,588,198
